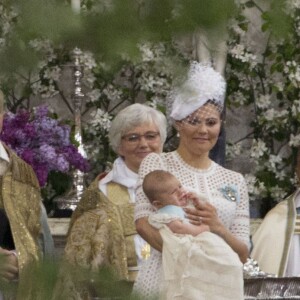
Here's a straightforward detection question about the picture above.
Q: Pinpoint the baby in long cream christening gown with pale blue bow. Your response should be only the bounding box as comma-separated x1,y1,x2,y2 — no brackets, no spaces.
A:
137,170,244,300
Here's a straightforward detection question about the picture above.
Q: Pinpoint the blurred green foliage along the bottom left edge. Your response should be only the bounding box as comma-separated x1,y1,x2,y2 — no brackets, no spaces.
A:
0,257,148,300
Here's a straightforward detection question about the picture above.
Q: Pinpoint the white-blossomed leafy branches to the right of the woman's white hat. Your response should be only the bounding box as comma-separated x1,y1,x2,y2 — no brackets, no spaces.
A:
227,1,300,210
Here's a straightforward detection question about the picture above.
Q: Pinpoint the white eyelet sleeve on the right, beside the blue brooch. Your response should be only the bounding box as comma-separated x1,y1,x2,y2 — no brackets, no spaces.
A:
230,174,250,248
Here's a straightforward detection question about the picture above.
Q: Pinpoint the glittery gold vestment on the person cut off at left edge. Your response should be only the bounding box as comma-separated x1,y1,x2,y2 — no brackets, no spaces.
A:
0,147,41,300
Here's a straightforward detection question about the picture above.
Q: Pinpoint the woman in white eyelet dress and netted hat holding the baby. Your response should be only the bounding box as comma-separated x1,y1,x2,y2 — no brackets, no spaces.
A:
134,62,250,299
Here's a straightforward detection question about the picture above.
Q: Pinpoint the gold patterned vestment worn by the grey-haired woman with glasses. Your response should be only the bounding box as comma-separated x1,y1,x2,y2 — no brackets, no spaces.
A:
65,178,141,298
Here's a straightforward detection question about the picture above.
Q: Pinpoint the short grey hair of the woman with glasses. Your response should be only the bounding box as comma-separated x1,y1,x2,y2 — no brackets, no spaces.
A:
108,103,167,153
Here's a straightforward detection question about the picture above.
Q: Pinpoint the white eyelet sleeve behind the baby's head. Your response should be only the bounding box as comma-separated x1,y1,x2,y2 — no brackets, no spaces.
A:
134,153,166,221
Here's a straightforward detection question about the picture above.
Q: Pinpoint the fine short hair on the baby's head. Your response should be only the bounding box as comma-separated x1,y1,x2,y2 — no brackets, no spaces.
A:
143,170,174,203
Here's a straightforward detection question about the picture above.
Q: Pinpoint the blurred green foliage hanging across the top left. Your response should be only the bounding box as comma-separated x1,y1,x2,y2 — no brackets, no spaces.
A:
0,0,235,73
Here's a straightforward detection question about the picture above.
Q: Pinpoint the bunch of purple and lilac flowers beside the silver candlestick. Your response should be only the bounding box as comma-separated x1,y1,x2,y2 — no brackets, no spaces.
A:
0,106,89,187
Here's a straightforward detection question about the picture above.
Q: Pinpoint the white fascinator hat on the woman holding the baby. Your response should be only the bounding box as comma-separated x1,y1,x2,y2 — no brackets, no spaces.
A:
170,61,226,121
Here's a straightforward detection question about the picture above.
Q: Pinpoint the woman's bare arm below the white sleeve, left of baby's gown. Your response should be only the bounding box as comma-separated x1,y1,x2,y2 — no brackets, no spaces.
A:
135,217,163,252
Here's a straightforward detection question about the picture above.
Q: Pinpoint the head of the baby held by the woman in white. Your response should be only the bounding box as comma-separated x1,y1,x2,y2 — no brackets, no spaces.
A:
143,170,187,208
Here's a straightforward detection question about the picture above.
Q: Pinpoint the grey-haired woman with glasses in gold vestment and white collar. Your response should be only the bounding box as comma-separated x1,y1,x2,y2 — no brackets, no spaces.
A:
65,104,166,299
